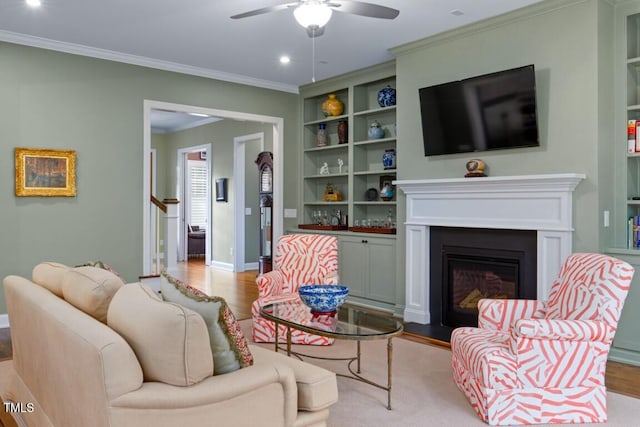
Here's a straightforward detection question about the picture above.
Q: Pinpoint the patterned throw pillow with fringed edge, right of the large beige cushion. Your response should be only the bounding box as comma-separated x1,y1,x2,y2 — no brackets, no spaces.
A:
160,271,253,375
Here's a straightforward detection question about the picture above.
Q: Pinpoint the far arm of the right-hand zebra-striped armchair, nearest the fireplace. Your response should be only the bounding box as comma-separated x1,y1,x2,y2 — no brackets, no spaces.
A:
478,299,547,332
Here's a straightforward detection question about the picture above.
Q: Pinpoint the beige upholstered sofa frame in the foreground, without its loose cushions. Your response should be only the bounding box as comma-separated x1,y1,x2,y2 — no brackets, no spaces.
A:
3,270,338,427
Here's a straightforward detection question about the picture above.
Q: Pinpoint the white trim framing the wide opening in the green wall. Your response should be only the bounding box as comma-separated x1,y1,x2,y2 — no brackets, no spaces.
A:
142,100,284,275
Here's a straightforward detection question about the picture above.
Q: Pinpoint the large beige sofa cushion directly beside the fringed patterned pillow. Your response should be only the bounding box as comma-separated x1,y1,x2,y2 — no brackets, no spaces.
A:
107,283,213,386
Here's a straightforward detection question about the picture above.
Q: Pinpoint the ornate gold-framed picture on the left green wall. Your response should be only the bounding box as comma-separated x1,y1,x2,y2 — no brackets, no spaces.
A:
15,148,76,197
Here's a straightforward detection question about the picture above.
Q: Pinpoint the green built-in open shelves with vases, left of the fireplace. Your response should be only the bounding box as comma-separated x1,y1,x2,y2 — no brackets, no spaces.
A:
299,67,397,231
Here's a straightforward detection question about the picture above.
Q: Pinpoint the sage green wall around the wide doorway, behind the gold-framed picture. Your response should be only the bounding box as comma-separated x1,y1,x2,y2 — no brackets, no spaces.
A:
0,43,298,313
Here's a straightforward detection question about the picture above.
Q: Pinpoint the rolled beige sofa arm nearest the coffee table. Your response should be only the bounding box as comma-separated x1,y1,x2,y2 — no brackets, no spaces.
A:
110,363,298,426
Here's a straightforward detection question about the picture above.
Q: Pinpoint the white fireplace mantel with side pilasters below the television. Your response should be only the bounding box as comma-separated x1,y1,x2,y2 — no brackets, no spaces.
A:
394,173,585,324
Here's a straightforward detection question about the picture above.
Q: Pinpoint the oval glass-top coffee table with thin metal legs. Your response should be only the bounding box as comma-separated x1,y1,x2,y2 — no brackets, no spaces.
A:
260,300,403,409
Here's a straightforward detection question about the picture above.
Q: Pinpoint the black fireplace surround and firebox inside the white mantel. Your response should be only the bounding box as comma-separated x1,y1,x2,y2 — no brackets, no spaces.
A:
430,227,537,328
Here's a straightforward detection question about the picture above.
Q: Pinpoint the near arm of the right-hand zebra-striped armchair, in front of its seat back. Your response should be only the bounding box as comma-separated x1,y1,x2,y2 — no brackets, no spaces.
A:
512,319,614,343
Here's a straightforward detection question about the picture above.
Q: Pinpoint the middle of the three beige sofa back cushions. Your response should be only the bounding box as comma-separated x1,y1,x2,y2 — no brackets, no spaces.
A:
62,267,123,323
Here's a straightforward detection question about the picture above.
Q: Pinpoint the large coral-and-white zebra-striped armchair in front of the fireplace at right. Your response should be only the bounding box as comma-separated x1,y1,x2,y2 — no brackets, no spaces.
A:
451,254,634,425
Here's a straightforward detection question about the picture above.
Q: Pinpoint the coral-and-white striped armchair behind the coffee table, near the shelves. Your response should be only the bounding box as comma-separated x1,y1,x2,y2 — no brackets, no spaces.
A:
251,234,339,345
